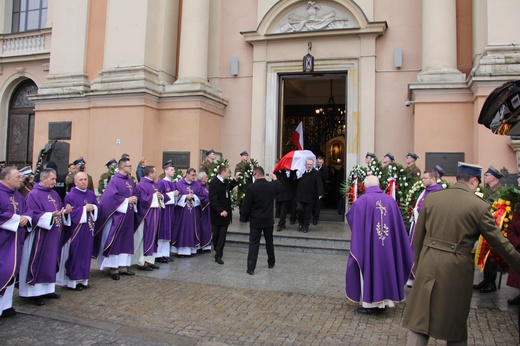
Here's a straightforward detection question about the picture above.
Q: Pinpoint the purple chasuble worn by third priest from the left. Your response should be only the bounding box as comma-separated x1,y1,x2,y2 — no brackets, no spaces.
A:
62,187,98,280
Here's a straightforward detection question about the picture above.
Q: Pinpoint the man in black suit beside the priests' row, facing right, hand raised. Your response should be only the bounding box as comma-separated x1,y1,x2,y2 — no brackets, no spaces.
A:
209,165,241,264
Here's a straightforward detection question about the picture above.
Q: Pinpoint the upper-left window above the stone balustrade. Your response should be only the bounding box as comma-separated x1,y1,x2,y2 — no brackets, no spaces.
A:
12,0,47,33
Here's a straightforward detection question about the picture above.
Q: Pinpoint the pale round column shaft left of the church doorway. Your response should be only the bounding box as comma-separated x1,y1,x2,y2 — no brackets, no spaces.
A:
176,0,210,84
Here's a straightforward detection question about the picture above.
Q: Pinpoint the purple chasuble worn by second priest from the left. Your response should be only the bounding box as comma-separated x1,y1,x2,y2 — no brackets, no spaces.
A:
26,184,63,285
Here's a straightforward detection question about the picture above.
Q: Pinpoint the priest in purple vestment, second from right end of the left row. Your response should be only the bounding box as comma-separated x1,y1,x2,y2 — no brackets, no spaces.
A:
172,168,200,256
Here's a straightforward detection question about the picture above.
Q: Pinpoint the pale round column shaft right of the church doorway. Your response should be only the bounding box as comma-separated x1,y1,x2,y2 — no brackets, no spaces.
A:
417,0,465,83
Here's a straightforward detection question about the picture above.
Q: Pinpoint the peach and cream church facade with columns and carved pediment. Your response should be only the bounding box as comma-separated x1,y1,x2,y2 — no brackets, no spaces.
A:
0,0,520,182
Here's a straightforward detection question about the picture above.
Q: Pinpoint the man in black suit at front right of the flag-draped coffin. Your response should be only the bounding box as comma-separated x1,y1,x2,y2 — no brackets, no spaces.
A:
294,159,323,233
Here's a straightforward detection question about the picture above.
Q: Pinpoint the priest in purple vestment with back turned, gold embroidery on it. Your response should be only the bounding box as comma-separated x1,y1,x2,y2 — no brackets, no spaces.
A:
345,176,413,314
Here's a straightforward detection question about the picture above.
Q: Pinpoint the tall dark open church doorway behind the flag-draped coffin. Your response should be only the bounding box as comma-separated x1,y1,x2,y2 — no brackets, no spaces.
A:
278,72,347,220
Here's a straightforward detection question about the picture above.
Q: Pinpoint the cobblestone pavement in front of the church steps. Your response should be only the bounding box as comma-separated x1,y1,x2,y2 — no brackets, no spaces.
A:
0,220,518,346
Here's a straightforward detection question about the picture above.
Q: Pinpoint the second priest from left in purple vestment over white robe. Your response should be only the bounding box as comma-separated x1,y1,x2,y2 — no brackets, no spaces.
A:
19,168,72,306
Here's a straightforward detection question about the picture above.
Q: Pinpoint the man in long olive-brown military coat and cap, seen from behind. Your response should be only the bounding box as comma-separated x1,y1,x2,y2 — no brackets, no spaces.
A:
403,162,520,345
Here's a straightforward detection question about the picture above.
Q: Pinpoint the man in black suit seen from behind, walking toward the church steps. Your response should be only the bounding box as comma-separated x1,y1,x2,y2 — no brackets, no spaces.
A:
242,167,281,275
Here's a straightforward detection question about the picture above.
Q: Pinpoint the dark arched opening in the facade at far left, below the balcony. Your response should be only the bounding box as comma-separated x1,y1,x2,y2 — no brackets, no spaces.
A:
7,80,38,166
